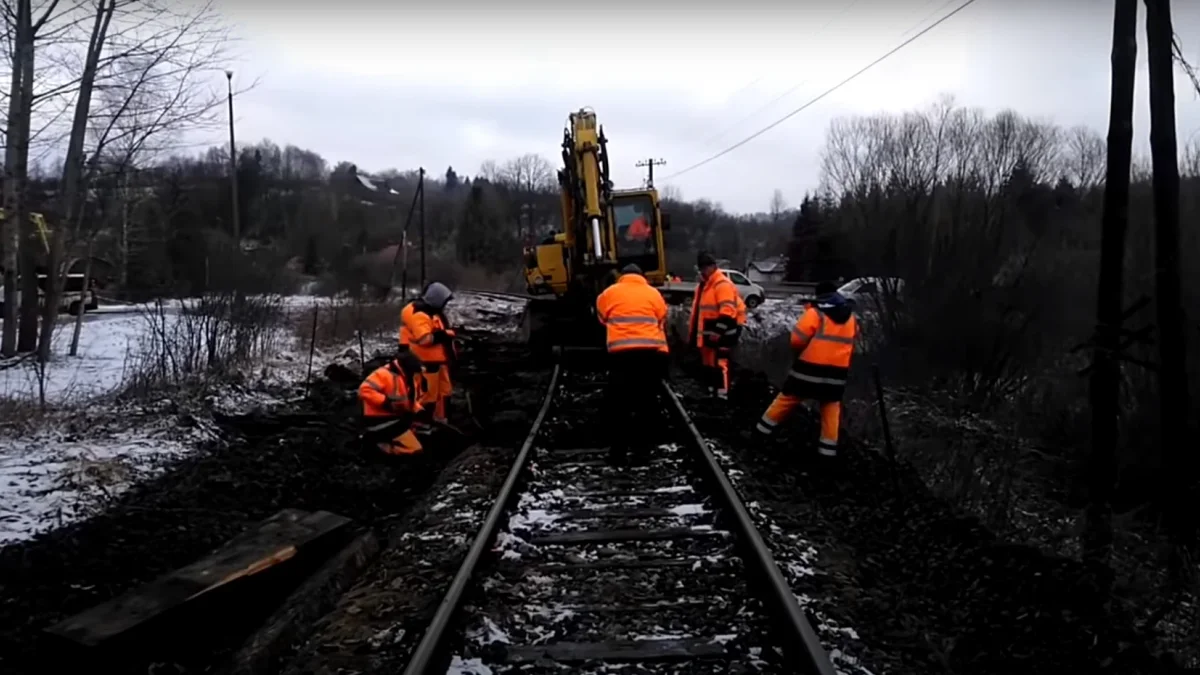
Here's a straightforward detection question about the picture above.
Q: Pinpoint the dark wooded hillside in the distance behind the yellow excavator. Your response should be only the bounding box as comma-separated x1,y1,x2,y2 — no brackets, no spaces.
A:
25,141,790,297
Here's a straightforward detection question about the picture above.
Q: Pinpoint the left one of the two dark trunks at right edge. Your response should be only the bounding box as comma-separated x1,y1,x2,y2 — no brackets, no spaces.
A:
1082,0,1138,569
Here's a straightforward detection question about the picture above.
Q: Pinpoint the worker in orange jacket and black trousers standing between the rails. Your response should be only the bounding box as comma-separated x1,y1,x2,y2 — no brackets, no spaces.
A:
596,264,668,462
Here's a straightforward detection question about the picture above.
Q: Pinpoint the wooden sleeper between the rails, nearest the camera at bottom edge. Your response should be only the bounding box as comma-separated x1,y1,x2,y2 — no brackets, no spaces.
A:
504,638,728,663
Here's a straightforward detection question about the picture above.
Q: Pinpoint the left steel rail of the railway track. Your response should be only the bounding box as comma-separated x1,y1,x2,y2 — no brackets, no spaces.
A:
404,364,563,675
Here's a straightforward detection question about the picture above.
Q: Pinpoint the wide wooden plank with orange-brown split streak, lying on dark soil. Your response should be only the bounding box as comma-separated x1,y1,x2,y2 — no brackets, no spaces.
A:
47,509,350,646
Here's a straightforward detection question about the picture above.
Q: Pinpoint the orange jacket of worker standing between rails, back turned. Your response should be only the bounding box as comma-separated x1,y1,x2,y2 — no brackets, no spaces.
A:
596,274,667,353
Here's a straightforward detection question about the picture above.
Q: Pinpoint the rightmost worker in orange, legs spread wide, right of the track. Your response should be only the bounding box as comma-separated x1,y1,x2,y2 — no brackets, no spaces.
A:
756,282,858,458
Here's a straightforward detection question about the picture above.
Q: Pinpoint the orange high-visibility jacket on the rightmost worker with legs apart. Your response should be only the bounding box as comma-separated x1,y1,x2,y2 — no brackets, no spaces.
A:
784,295,858,401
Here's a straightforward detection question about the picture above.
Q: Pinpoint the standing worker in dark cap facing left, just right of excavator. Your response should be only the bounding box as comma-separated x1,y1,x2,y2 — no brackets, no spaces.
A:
688,252,740,399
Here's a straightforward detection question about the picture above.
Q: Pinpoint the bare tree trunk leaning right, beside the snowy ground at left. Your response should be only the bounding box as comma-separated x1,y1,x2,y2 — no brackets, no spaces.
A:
37,0,116,363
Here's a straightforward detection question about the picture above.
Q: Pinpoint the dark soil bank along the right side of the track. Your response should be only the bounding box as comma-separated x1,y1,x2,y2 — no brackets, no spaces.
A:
676,371,1180,675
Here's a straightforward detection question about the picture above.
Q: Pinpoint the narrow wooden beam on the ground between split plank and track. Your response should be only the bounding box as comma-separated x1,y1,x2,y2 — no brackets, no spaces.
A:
229,532,379,675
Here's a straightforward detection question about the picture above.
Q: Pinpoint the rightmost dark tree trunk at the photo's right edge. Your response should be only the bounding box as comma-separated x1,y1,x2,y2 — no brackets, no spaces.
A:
1146,0,1195,578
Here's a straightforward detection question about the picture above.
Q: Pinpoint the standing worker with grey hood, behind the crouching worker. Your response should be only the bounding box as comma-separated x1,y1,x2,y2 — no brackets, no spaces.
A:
400,281,458,422
